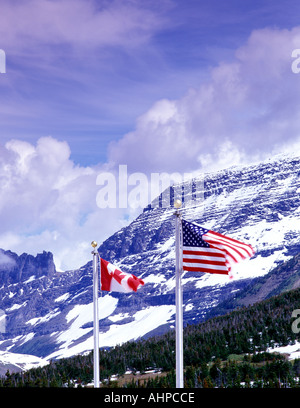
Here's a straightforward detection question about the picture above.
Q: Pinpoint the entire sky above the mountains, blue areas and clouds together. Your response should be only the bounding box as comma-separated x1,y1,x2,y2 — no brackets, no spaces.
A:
0,0,300,269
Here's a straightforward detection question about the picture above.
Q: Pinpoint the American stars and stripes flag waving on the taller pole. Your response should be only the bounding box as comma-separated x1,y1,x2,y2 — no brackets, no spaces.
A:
182,220,254,275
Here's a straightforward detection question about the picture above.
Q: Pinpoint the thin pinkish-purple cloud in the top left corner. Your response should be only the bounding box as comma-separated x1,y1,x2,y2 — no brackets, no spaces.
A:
0,0,169,52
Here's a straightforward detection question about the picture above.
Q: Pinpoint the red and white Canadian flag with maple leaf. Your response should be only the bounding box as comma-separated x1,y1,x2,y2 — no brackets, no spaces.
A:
101,258,144,293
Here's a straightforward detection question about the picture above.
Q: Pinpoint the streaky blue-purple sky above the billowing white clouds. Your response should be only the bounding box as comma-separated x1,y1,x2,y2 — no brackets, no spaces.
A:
0,0,299,165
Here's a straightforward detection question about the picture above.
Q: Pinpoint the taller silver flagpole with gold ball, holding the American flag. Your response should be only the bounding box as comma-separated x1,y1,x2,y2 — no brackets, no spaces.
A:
174,199,183,388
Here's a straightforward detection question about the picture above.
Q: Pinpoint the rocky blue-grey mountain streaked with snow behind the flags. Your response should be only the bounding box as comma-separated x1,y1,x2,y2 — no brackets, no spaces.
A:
0,156,300,360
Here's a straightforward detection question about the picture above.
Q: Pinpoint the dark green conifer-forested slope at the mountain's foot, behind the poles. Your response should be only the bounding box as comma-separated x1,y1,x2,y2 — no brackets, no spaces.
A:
0,289,300,387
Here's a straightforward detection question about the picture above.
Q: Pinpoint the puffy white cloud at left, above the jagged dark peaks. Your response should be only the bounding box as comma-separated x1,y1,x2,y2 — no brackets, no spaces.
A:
0,137,129,270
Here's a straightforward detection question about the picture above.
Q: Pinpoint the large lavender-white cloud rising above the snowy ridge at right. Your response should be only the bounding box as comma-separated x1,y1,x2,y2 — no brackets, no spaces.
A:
109,27,300,175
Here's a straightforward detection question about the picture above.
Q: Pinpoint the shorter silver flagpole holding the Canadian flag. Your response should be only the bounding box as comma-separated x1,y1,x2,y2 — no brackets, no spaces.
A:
91,241,100,388
